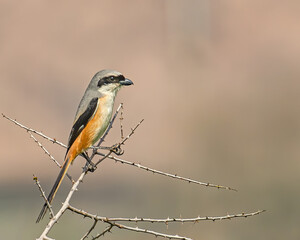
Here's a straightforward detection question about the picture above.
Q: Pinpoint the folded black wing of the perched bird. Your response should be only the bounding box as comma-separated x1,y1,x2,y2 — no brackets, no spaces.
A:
67,98,98,152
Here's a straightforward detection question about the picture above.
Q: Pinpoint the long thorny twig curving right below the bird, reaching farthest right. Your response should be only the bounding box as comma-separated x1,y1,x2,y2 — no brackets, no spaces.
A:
68,205,266,224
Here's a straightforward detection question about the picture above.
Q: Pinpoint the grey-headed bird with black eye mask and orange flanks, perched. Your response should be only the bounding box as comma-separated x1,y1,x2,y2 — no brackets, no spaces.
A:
36,69,133,223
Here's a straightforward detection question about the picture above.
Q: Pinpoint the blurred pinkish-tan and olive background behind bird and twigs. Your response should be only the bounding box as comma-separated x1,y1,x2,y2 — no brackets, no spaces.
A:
0,0,300,240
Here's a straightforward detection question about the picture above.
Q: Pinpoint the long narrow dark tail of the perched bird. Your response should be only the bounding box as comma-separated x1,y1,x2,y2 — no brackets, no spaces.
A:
36,155,73,223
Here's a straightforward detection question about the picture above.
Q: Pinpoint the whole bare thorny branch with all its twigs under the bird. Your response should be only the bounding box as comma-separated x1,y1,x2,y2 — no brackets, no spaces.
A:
2,107,264,240
